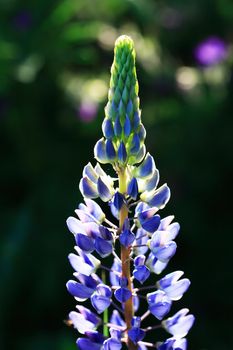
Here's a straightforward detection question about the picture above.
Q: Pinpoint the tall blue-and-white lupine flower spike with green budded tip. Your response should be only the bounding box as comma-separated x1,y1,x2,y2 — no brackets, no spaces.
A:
64,36,194,350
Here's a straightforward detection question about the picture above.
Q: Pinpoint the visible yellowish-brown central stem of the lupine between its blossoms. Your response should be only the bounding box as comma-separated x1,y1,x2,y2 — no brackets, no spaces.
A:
118,168,138,350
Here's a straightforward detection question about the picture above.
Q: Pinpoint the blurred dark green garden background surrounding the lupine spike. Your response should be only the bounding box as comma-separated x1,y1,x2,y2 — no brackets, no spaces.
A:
0,0,233,350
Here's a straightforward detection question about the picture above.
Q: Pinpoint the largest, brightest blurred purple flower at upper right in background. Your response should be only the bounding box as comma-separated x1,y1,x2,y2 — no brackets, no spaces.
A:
194,37,227,66
